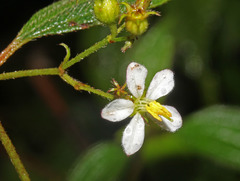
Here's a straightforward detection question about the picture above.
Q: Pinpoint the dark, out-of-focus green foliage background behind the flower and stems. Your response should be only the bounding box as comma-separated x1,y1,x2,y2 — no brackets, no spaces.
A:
0,0,240,181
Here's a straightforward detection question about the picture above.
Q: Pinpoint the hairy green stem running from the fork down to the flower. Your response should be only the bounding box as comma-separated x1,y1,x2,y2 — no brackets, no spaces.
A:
61,73,114,100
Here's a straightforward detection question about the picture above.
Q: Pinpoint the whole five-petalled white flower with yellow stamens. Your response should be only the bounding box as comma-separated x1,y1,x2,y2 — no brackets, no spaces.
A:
101,62,182,155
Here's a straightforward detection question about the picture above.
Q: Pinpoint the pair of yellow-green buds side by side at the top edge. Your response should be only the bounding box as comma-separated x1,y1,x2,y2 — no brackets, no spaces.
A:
94,0,159,36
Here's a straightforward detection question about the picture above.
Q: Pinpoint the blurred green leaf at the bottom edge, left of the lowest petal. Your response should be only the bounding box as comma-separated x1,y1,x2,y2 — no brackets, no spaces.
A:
68,143,127,181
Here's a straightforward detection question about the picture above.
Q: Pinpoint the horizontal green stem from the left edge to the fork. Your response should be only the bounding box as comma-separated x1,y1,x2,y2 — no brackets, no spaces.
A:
0,68,59,80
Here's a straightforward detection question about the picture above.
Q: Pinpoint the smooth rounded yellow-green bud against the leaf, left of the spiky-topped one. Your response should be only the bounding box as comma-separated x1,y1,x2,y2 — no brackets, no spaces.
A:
94,0,120,25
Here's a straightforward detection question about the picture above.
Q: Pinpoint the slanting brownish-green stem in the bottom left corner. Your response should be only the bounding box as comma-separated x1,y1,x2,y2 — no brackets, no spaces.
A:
0,122,30,181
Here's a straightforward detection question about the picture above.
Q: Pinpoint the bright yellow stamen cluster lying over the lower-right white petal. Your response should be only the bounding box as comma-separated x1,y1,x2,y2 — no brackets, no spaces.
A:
146,101,172,121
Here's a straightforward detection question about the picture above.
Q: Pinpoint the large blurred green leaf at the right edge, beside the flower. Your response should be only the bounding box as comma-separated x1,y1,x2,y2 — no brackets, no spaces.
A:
179,106,240,168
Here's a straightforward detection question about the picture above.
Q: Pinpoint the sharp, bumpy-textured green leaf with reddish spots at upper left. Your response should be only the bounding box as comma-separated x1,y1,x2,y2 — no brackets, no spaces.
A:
18,0,99,40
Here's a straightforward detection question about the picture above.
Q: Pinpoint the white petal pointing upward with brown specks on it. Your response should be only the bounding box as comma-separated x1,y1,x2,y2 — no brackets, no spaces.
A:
127,62,147,98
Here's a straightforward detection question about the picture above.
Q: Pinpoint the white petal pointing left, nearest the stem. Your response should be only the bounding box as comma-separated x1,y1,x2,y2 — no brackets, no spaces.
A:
101,99,134,122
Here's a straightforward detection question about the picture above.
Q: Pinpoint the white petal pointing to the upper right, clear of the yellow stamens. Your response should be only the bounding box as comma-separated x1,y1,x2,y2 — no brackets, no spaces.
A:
146,69,174,100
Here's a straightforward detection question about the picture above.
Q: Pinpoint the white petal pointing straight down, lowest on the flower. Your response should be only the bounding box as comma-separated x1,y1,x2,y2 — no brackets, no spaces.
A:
122,113,145,155
